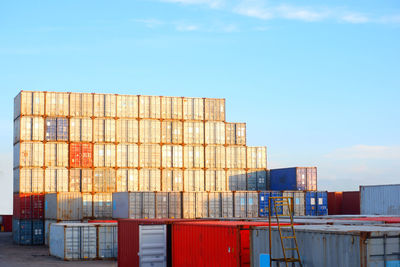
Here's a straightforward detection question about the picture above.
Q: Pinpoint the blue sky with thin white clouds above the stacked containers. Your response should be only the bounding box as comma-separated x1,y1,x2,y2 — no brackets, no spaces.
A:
0,0,400,214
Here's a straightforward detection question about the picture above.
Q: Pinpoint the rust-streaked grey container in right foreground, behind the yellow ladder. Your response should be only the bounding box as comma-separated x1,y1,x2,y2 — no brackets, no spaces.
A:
250,225,400,267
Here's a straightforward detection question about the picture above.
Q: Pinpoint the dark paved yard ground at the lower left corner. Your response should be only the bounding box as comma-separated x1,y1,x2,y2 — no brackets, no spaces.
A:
0,233,117,267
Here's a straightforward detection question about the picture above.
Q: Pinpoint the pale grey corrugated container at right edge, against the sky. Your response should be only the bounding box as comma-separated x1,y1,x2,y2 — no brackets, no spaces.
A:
360,185,400,215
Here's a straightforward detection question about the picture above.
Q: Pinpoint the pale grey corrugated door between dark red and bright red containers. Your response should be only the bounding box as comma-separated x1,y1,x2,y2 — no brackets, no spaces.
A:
139,225,167,267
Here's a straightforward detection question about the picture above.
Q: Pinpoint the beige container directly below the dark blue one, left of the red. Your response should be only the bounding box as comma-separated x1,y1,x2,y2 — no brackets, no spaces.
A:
44,142,69,167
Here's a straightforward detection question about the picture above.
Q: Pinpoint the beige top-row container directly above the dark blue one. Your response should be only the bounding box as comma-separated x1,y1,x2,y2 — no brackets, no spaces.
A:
46,92,69,116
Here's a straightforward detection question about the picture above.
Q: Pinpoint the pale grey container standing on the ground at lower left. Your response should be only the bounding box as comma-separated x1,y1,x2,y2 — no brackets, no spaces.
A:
49,223,97,260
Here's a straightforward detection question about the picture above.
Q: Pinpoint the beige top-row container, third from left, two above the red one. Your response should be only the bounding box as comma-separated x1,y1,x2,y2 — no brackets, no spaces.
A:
69,93,93,117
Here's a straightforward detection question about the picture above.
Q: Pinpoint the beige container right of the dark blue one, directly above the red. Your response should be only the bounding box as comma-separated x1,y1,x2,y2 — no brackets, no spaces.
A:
69,118,93,142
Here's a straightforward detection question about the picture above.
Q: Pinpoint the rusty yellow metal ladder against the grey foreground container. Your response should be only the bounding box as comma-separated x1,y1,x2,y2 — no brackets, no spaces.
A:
268,196,303,267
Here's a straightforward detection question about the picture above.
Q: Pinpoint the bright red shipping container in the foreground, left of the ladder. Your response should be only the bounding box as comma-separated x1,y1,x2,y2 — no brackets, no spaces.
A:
172,221,290,267
